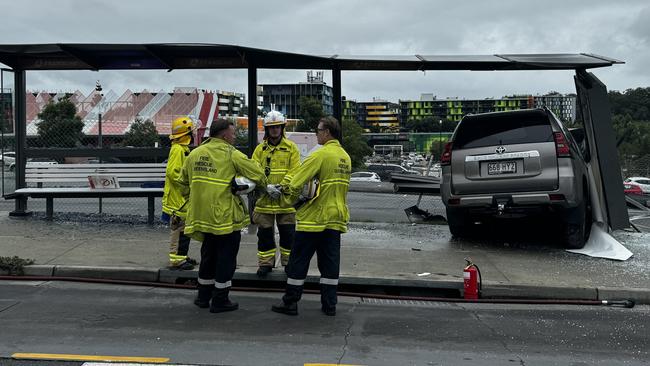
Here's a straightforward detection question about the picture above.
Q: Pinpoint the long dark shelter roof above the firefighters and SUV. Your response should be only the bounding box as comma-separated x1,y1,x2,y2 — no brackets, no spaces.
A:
0,43,623,71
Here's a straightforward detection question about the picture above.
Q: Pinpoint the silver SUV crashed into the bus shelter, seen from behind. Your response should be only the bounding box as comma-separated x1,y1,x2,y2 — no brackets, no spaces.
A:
440,108,591,248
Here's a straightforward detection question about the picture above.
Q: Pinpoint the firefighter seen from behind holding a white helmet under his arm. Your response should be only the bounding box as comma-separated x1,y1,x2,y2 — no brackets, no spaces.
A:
180,119,266,313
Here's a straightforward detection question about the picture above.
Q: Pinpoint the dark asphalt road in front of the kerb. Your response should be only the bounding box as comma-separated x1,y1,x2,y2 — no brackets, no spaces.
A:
0,281,650,366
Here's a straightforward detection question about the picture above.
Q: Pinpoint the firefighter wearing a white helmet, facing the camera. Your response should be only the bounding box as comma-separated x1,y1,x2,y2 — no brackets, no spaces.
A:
253,110,300,278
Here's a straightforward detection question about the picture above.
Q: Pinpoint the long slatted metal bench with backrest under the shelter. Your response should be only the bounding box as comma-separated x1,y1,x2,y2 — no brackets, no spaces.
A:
6,163,166,224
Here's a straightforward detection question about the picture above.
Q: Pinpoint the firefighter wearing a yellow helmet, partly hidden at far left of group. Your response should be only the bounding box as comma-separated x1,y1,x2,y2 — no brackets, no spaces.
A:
162,116,198,270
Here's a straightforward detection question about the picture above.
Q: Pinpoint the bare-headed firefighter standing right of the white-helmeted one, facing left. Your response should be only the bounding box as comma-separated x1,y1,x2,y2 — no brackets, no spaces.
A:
271,117,351,316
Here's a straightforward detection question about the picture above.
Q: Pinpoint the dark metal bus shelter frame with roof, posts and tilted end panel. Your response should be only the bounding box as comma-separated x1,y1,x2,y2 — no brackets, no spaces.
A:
0,43,628,229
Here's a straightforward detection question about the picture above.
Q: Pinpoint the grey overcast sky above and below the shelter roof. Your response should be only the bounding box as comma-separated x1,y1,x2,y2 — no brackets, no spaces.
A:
0,0,650,101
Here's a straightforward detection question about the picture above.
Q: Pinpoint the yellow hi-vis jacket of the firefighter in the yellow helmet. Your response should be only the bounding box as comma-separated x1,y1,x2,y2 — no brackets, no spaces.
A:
162,142,190,219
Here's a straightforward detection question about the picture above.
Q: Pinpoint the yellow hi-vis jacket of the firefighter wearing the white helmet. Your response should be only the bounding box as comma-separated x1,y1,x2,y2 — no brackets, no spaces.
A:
253,136,300,214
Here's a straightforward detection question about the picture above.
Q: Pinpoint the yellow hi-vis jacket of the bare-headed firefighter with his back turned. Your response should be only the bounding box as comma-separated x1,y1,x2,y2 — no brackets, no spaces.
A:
180,137,266,241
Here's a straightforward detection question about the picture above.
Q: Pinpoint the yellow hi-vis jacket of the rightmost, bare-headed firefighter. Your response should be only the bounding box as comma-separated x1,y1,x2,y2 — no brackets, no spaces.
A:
281,139,352,233
